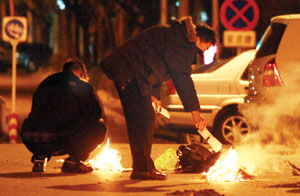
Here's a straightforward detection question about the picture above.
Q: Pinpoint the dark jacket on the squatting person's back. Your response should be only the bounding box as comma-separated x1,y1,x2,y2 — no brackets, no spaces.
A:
21,72,102,141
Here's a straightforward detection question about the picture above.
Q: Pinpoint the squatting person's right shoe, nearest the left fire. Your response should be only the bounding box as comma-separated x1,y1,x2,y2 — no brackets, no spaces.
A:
61,159,93,173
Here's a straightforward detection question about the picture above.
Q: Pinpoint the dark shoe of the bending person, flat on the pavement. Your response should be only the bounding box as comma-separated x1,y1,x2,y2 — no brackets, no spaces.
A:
130,170,167,180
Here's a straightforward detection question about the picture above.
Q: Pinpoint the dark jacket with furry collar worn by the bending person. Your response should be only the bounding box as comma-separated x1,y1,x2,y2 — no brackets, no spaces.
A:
101,16,200,112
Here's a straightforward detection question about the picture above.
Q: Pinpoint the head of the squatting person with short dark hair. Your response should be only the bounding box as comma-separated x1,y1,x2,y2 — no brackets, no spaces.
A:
63,58,89,81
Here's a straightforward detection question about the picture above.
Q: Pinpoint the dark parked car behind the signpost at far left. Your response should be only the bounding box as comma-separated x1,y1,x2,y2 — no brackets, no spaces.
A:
0,41,52,72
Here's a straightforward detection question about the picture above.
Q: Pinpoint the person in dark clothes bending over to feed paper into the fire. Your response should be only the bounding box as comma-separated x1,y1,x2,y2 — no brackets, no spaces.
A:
101,17,215,180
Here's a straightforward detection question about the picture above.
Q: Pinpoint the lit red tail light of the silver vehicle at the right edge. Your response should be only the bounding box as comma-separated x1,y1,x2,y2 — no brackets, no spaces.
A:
263,59,283,86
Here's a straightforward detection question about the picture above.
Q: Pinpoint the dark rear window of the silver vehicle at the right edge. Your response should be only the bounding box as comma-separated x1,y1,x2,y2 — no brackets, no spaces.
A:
256,23,286,58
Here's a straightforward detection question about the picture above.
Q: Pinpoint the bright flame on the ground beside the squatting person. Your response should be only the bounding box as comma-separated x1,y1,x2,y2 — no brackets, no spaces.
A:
88,139,124,171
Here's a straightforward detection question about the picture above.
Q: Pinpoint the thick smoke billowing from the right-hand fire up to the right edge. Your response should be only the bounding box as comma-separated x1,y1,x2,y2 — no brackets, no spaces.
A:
236,67,300,175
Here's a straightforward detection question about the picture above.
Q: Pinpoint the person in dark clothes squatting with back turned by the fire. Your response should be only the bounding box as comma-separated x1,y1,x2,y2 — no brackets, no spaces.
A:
21,59,106,173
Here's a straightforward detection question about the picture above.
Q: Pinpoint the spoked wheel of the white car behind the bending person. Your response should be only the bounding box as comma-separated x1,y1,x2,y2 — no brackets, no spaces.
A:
214,109,251,144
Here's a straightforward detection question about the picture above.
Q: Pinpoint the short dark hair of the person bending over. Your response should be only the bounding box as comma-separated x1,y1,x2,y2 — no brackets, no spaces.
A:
196,23,216,45
